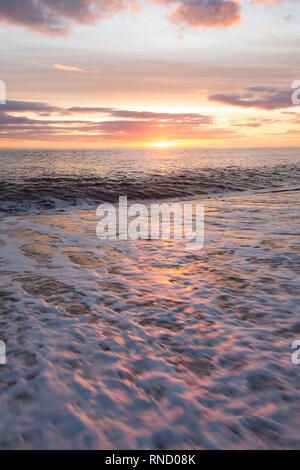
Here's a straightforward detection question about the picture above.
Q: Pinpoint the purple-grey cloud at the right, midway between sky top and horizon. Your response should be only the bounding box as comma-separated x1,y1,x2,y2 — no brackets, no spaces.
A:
209,87,293,111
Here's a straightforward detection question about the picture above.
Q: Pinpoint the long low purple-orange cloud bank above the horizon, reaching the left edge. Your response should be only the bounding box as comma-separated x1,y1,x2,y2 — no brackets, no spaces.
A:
0,101,226,143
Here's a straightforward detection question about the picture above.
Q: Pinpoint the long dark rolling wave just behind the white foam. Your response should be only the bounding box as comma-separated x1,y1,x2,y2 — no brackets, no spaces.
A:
0,165,300,211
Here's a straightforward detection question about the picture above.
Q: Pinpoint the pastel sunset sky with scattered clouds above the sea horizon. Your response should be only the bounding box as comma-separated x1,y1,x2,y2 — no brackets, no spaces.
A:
0,0,300,148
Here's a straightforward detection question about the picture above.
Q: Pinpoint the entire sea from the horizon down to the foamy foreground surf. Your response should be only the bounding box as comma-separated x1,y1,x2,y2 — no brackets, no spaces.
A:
0,149,300,449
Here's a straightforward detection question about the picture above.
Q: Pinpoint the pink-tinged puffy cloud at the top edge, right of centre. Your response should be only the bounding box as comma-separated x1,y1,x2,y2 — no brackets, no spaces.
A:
166,0,241,27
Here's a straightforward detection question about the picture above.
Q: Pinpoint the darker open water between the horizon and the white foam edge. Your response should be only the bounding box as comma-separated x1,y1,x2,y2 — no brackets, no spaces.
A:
0,148,300,211
